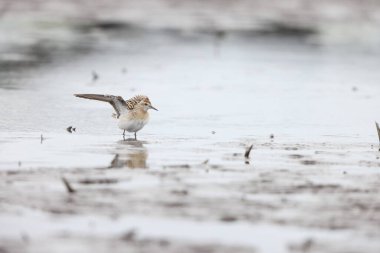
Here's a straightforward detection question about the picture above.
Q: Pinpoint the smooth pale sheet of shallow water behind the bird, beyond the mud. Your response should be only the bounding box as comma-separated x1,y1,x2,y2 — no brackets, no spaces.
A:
0,33,380,169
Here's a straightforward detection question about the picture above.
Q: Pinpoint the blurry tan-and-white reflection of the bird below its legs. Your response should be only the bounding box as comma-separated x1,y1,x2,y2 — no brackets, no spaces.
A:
109,139,148,169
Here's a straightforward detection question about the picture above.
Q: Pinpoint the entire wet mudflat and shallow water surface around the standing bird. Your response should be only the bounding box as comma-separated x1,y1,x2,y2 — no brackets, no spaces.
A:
0,9,380,253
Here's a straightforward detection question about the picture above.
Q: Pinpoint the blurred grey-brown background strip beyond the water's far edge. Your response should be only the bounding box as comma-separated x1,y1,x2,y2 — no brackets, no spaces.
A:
0,0,380,64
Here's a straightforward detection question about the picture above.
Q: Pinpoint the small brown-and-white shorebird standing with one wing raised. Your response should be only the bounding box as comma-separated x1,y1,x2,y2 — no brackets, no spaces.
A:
74,94,158,140
